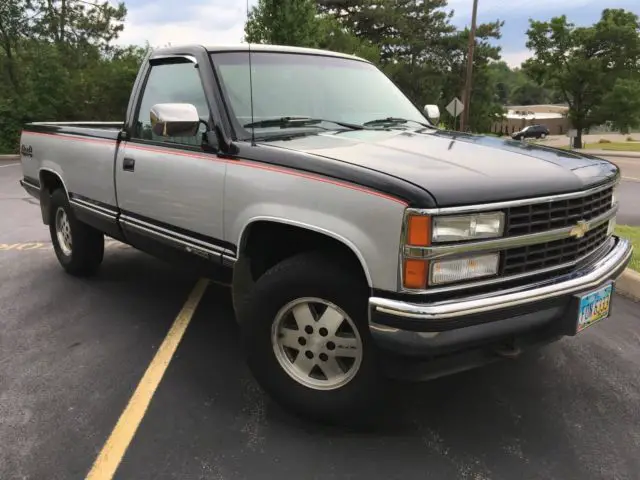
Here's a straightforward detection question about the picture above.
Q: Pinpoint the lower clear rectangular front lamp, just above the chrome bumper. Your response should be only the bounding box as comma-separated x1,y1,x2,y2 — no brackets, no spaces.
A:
429,253,500,285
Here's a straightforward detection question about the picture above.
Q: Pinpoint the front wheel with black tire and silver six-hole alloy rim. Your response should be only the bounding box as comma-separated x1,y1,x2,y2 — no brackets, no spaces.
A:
238,253,384,423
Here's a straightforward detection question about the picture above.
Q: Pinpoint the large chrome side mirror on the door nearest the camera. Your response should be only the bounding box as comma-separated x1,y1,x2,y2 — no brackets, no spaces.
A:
149,103,200,137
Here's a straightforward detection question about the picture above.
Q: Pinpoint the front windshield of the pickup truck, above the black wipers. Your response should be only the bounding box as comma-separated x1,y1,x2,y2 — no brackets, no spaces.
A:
212,52,429,138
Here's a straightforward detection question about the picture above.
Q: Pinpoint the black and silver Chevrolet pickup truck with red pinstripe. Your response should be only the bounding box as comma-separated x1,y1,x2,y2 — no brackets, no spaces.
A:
21,45,632,418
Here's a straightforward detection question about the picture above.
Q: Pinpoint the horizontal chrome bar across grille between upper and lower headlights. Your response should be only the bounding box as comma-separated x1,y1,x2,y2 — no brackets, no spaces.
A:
403,203,620,260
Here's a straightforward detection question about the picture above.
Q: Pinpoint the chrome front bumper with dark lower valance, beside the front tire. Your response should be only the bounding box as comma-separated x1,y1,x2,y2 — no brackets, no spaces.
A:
369,237,633,353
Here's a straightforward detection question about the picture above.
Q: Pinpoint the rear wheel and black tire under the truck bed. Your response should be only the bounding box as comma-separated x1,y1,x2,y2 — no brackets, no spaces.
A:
49,189,104,276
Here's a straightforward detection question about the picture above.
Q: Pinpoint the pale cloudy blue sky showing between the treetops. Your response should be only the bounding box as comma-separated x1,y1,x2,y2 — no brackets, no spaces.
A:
110,0,640,67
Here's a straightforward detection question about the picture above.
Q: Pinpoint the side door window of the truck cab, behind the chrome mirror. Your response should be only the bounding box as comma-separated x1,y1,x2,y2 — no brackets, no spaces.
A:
133,62,209,146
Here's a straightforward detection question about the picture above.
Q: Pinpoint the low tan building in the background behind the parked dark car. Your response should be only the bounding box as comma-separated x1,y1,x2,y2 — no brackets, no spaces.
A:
491,105,571,135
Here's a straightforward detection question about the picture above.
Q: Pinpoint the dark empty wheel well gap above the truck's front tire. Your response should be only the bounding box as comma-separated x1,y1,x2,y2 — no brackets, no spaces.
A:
239,221,368,282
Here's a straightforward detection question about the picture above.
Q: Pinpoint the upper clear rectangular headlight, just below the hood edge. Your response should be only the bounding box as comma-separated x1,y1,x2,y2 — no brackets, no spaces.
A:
432,212,504,242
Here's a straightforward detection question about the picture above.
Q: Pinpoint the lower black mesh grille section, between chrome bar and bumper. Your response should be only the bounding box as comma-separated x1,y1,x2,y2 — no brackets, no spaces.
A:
501,223,608,275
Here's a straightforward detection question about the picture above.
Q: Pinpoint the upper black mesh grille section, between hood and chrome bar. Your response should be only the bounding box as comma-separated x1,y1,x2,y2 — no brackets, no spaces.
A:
505,187,613,236
